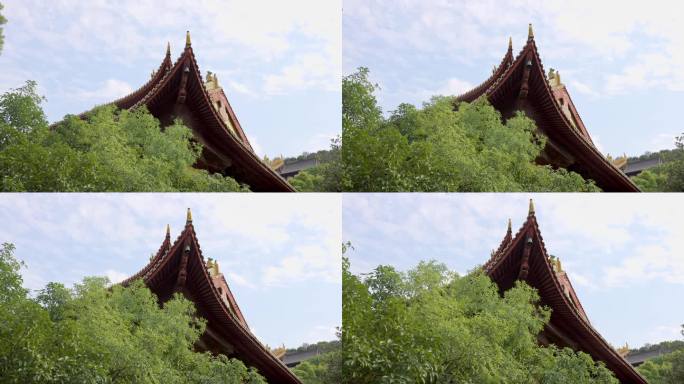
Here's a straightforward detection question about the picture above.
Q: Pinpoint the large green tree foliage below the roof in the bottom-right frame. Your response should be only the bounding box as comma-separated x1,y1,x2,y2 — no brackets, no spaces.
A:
342,252,617,384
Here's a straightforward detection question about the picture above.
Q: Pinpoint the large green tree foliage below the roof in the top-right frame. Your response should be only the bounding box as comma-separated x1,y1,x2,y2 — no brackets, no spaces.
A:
341,68,598,191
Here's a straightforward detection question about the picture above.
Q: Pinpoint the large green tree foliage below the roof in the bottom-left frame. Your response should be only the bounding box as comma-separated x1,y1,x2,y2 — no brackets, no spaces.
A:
0,244,265,384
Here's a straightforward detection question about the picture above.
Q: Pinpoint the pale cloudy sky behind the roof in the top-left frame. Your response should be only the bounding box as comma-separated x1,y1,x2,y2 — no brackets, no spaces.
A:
0,0,342,158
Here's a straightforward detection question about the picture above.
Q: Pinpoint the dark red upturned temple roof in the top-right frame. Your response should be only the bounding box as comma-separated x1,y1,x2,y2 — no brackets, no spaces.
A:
455,25,639,192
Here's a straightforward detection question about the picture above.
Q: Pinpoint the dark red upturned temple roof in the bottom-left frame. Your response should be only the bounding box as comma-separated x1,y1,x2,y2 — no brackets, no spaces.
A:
121,209,300,384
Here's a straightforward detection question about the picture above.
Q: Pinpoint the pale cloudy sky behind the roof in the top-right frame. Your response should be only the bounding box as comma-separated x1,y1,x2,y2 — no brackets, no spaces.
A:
342,0,684,156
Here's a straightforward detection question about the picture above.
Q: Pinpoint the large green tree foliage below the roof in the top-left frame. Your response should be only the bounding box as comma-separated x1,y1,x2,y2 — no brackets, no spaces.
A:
0,81,246,192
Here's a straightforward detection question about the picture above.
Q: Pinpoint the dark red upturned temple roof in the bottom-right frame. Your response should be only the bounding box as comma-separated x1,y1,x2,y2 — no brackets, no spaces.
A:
483,200,646,384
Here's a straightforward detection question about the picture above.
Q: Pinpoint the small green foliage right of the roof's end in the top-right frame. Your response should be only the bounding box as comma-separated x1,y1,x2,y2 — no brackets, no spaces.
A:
632,134,684,192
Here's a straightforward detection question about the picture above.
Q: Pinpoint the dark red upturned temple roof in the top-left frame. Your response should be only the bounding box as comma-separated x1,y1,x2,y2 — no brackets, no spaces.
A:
73,32,294,192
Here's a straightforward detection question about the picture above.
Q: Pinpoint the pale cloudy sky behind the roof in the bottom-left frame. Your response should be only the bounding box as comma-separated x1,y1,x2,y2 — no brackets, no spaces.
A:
0,193,342,348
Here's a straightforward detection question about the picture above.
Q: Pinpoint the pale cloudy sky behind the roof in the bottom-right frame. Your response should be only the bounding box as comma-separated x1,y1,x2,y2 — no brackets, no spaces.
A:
342,193,684,348
